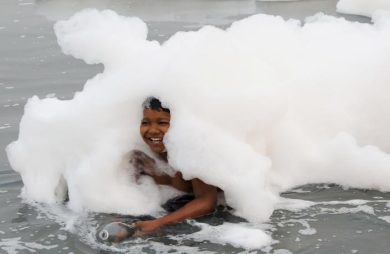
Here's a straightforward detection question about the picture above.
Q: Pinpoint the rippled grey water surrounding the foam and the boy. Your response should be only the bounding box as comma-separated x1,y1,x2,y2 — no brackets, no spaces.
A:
0,0,390,254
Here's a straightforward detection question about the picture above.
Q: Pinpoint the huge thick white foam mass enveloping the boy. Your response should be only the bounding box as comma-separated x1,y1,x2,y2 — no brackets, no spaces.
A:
7,10,390,222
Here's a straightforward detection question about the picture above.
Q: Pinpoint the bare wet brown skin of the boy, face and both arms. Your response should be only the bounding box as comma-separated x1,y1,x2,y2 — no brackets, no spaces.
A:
131,109,217,234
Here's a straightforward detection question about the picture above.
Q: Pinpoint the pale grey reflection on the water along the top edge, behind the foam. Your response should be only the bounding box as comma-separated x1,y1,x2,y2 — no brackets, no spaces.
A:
35,0,256,24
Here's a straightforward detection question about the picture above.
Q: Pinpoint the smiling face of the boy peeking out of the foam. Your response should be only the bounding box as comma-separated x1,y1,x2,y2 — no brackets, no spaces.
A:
140,109,171,154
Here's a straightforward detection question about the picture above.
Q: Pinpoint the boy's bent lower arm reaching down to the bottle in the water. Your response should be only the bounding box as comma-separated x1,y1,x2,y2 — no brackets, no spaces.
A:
136,179,217,233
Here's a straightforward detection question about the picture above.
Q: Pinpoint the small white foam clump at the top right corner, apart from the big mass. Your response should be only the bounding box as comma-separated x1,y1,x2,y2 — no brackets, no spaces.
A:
337,0,390,17
